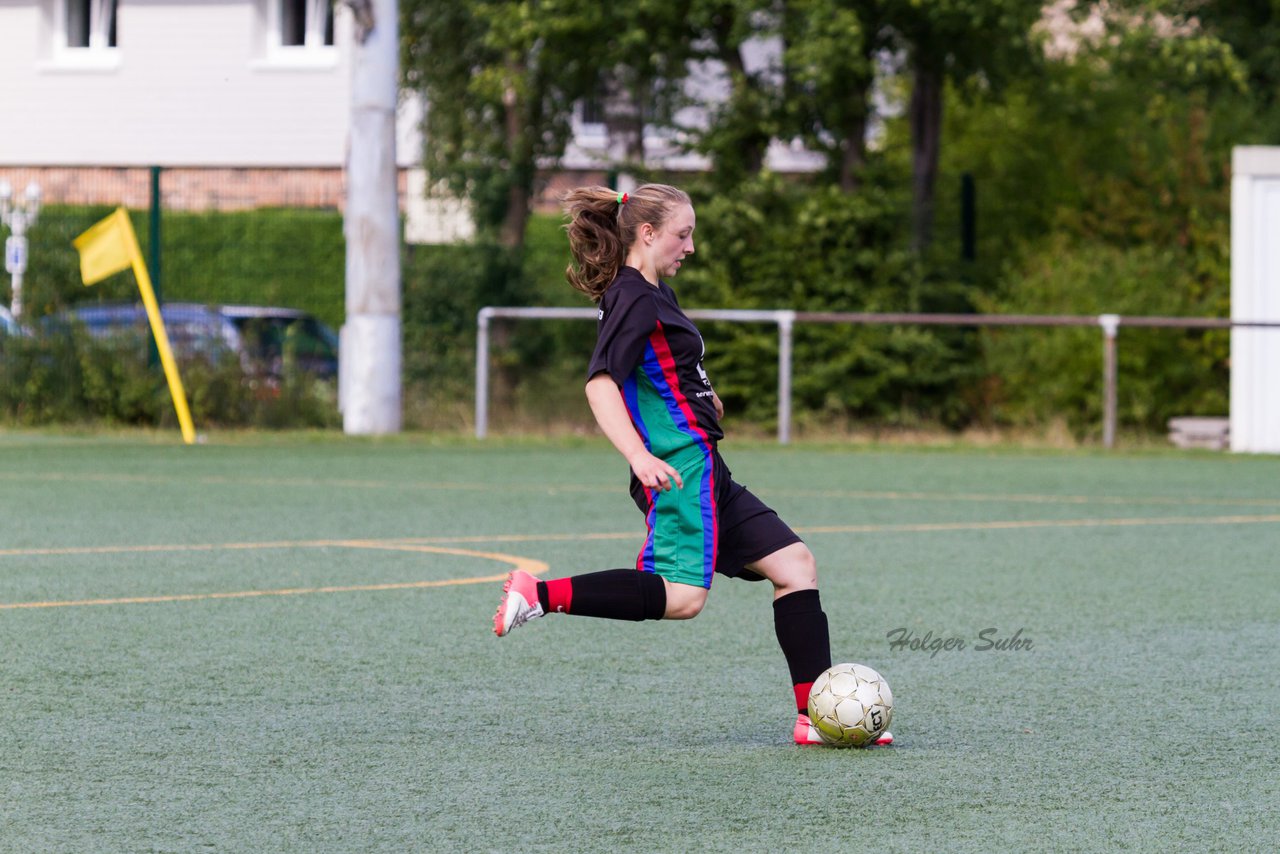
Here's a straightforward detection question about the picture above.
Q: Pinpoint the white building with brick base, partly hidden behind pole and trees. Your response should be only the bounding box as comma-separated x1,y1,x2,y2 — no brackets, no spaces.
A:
0,0,818,224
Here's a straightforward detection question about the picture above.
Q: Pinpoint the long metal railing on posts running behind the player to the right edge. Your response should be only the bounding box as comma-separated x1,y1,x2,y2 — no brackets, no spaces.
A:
475,306,1280,448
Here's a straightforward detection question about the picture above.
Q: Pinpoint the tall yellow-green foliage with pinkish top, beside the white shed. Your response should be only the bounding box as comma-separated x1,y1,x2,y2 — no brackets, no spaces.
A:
945,4,1245,434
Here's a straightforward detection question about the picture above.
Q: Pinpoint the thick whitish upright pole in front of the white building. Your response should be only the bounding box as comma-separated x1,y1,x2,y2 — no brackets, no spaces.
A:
339,0,402,435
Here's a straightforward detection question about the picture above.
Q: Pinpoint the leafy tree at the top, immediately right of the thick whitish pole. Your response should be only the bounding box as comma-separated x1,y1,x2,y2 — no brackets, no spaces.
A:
402,0,604,248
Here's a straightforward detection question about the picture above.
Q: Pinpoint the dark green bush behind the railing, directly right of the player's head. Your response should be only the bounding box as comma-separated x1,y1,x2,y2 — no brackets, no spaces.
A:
675,175,977,426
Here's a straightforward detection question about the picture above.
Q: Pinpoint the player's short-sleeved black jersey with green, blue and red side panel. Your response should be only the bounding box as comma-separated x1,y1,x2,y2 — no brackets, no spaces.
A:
588,266,724,457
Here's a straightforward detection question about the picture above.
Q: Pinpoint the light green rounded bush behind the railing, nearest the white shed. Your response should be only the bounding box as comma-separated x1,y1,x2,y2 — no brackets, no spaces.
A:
983,237,1230,435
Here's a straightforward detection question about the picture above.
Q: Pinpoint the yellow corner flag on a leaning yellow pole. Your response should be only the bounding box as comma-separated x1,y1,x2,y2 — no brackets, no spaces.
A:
73,207,196,444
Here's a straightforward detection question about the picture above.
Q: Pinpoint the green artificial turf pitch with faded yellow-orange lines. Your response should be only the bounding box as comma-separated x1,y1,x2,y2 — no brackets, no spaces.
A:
0,434,1280,851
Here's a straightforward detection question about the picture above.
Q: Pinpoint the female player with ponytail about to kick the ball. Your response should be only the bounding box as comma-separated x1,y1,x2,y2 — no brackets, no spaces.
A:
493,184,892,744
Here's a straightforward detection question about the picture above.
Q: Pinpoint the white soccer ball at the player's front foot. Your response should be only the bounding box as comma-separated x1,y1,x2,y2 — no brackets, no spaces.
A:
809,665,893,748
